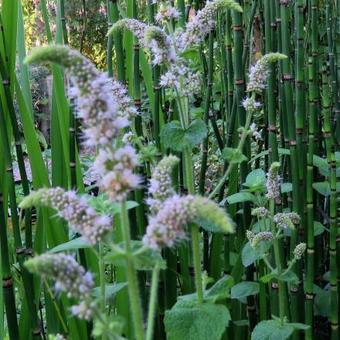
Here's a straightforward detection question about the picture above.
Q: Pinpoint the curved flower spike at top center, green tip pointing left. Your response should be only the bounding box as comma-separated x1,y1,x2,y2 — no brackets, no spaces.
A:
108,19,176,65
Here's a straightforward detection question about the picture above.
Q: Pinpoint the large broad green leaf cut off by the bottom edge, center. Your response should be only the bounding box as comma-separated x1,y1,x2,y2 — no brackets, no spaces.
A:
164,300,231,340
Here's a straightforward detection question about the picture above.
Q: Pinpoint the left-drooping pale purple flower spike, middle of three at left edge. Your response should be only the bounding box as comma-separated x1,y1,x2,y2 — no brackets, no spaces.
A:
20,187,112,245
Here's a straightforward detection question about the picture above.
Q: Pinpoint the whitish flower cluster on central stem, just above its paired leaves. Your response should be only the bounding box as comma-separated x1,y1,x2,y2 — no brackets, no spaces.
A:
159,61,201,98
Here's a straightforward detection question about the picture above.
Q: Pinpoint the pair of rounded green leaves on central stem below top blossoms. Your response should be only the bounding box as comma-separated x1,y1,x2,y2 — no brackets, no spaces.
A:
161,119,207,151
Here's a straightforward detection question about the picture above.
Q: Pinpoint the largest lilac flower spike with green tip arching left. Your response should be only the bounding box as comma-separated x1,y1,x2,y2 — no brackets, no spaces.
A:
26,45,139,201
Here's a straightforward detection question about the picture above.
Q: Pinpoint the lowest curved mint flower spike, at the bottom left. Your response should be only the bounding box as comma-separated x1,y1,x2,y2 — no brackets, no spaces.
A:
25,254,95,320
